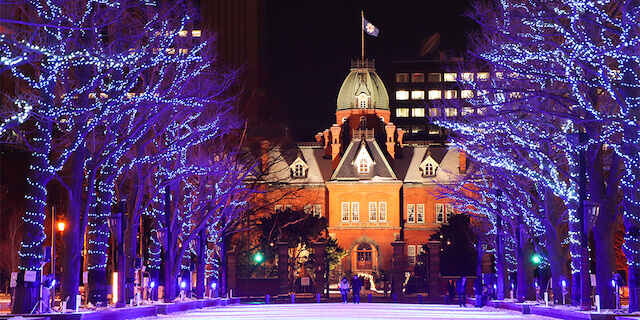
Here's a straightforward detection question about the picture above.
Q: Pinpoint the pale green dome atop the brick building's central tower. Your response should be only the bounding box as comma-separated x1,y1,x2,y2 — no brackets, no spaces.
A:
337,60,389,111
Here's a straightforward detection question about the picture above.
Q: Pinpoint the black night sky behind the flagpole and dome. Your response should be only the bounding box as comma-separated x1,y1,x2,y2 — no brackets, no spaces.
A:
266,0,471,139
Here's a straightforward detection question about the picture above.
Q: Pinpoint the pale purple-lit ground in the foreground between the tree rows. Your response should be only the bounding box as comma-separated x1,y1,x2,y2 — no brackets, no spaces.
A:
159,303,553,320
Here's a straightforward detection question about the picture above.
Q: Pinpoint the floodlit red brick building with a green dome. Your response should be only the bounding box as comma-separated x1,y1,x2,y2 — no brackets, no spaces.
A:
252,60,466,284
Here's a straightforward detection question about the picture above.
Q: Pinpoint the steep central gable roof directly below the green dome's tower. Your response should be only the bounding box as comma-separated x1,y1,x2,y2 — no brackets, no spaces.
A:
331,139,398,181
